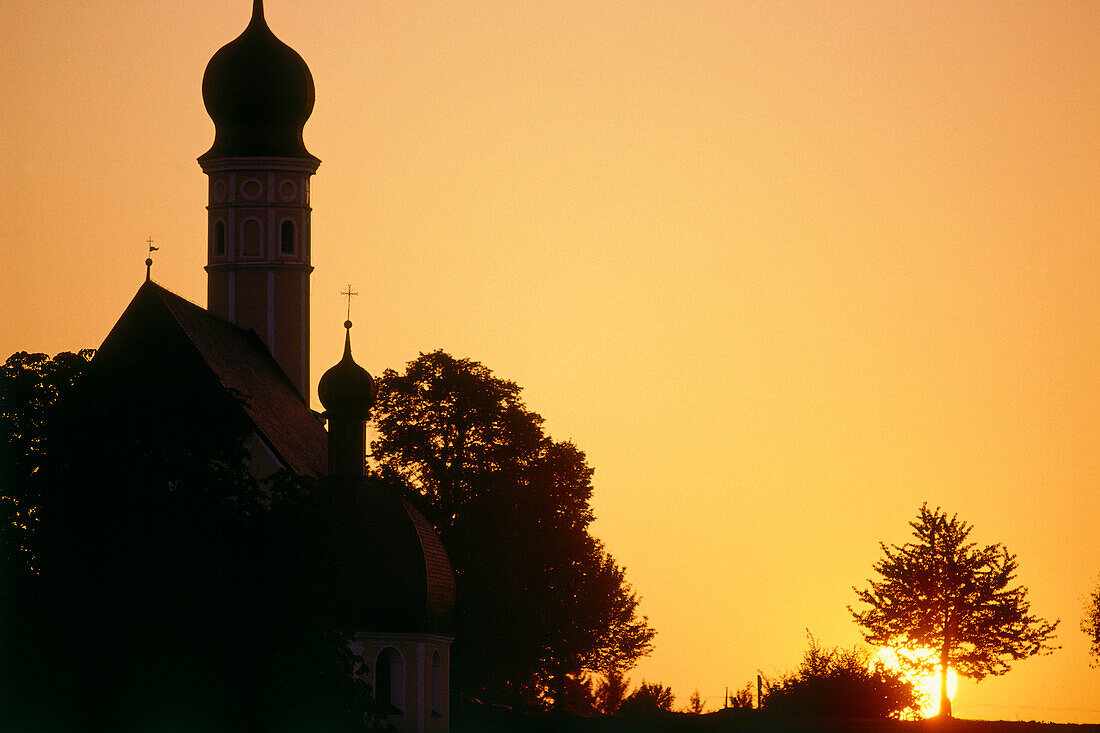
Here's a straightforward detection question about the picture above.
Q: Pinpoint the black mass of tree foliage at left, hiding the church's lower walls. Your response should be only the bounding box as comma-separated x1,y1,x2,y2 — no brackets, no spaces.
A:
0,354,381,731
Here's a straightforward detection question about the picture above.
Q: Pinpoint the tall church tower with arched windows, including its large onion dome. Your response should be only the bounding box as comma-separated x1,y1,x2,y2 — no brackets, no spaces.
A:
198,0,320,400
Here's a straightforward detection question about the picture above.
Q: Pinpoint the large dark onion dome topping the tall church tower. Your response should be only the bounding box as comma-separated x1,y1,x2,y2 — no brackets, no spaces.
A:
199,0,316,161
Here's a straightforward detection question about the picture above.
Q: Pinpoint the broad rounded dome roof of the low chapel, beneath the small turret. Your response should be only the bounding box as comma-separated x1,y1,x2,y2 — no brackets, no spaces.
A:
316,475,454,634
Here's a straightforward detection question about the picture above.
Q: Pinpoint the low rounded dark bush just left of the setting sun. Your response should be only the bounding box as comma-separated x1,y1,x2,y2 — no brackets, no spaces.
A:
763,634,921,720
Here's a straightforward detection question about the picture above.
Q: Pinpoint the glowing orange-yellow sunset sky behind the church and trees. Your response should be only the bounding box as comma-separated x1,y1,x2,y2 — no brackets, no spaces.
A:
0,0,1100,722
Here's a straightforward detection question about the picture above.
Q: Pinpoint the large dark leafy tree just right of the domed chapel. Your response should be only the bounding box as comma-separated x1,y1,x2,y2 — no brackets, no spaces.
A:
371,351,653,705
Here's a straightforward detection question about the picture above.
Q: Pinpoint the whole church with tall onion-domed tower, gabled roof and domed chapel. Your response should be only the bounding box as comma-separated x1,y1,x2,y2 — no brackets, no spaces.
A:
49,0,454,731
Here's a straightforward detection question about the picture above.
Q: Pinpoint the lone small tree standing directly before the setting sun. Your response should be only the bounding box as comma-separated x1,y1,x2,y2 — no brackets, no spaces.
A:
848,504,1058,718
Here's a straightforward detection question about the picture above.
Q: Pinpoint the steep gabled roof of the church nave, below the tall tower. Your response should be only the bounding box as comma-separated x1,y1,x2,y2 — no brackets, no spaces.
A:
94,281,328,475
